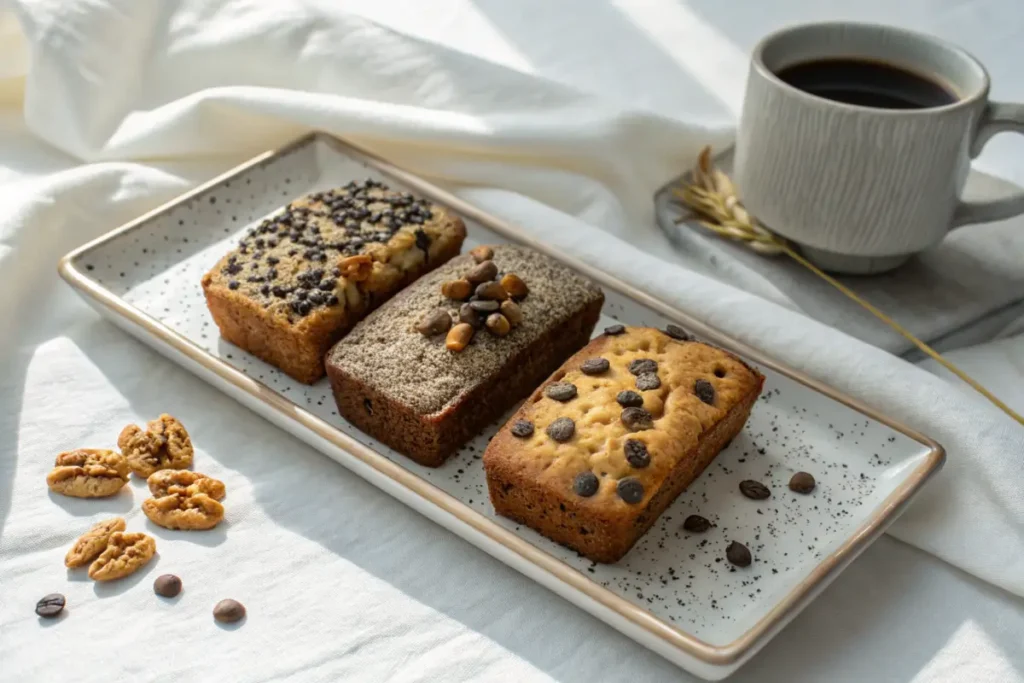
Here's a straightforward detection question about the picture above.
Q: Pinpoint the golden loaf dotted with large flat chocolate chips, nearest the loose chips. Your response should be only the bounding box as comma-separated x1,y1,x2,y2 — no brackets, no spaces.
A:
483,326,764,562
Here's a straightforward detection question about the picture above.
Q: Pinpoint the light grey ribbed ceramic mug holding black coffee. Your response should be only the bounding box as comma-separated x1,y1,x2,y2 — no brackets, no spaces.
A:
735,23,1024,273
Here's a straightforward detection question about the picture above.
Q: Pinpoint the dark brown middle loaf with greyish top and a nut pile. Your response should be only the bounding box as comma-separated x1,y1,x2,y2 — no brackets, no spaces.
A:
327,245,604,467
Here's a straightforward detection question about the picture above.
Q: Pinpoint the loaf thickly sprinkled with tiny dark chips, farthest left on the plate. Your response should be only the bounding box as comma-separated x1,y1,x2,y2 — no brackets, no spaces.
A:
203,180,466,383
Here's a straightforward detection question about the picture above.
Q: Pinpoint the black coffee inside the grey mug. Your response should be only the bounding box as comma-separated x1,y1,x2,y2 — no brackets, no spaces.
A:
775,57,957,110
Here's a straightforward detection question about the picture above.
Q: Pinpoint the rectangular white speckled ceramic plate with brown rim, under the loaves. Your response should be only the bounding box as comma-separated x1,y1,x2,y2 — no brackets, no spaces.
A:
60,134,943,679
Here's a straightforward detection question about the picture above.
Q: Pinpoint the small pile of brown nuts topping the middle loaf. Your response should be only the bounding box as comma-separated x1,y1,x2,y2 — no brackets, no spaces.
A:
416,246,529,352
